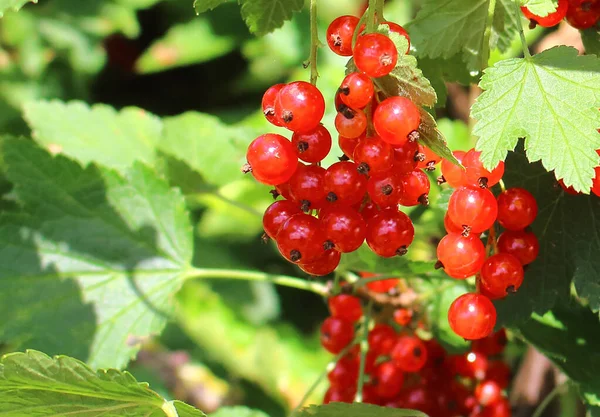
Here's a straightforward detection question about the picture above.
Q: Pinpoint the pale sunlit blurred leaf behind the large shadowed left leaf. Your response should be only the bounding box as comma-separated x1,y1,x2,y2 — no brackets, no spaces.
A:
25,101,162,172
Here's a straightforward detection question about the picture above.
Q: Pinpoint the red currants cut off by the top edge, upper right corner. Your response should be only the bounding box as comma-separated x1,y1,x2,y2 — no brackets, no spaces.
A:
521,0,600,30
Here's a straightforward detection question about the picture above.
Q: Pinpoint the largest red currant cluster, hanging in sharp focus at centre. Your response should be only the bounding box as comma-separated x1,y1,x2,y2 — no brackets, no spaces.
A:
244,16,439,275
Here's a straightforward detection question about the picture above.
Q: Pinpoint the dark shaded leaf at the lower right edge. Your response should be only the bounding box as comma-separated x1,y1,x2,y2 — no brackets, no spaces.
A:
518,302,600,406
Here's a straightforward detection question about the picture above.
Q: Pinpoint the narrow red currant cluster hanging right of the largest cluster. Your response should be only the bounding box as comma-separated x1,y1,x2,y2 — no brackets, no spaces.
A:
437,149,539,340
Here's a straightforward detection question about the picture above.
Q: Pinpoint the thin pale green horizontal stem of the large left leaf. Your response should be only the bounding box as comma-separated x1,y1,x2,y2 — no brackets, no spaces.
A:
185,268,329,297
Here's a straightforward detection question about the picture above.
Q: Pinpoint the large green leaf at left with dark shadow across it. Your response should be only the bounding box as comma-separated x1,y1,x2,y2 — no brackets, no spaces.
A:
0,139,193,368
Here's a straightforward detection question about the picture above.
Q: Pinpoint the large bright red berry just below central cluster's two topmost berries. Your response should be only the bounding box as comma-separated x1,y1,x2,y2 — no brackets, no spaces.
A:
353,33,398,78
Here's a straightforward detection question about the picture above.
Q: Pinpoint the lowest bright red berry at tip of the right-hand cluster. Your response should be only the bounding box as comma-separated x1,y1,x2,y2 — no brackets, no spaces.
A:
448,294,496,340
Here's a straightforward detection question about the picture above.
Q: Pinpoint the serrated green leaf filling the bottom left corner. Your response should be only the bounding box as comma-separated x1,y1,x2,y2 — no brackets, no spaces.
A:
0,350,204,417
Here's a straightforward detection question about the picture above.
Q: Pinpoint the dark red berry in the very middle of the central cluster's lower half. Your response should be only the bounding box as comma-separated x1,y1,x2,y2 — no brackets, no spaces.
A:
325,161,367,206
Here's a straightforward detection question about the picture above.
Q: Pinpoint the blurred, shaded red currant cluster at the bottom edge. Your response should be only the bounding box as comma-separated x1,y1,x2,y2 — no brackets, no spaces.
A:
321,294,511,417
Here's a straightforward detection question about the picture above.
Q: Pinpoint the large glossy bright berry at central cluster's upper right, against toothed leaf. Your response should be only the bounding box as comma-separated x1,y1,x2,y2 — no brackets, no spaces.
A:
373,97,421,146
